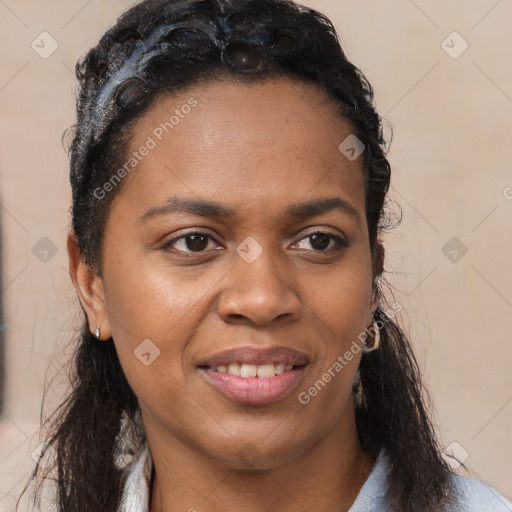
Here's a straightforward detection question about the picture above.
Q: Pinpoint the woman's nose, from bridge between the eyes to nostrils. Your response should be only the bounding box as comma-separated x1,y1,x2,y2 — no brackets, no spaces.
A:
217,251,302,326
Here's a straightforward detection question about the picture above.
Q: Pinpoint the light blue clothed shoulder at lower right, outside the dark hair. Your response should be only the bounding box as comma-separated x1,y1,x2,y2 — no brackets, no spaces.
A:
450,475,512,512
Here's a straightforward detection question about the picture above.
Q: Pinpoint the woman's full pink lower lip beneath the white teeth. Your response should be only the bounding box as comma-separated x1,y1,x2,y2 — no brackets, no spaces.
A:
201,366,306,405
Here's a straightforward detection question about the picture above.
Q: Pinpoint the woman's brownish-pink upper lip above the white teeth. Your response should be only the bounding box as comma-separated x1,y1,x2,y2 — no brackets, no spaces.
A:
198,346,309,368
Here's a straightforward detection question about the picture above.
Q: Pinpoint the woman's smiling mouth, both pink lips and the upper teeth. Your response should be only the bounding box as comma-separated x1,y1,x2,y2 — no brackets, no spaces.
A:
198,347,309,405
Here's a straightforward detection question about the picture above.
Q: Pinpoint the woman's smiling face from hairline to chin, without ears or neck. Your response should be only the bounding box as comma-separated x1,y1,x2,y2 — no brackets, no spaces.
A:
94,80,376,468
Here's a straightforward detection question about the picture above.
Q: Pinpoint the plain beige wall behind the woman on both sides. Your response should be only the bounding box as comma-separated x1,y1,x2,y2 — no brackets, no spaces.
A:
0,0,512,512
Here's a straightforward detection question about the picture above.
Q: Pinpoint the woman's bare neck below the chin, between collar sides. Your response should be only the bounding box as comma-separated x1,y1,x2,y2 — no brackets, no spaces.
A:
147,400,375,512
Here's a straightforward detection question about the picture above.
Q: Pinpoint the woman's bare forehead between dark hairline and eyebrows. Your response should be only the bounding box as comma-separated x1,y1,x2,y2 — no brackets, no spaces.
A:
117,80,364,215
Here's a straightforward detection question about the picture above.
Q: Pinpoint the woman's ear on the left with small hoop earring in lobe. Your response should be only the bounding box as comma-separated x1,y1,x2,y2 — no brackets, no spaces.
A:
67,231,112,340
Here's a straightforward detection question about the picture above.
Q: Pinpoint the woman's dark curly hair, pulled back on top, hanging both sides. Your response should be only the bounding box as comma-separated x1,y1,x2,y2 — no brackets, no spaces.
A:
22,0,458,512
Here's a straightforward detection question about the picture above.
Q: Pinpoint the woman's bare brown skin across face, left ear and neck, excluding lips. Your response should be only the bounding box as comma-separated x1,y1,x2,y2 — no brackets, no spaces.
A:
68,80,381,512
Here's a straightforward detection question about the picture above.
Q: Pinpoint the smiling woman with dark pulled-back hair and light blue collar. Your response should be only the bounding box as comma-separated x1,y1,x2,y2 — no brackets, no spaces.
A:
22,0,511,512
